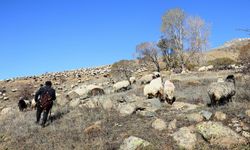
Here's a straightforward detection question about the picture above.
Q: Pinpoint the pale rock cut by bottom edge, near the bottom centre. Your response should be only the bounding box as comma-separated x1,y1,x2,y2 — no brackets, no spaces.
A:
119,136,153,150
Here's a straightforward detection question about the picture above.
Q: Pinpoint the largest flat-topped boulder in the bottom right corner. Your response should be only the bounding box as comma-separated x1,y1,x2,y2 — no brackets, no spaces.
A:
196,121,246,148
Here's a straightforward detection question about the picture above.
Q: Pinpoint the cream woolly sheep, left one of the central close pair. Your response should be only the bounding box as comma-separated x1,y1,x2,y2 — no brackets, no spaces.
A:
144,78,163,98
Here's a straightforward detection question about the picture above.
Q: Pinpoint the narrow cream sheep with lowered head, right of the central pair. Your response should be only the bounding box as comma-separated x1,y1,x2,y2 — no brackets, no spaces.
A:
163,80,175,105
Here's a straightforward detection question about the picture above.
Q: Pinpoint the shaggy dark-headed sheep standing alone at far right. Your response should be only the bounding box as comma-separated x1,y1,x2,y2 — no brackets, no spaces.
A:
207,75,236,106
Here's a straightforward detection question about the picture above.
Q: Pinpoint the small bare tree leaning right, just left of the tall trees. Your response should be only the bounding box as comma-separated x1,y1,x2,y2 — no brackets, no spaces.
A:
136,42,160,72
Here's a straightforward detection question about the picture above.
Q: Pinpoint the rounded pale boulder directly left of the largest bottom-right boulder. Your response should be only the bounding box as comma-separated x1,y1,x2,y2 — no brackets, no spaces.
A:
172,127,197,150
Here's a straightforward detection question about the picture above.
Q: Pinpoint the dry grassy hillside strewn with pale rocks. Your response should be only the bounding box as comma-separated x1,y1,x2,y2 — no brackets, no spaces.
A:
0,39,250,150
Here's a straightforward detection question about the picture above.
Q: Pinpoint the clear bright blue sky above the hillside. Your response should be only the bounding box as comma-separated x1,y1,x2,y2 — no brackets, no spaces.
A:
0,0,250,79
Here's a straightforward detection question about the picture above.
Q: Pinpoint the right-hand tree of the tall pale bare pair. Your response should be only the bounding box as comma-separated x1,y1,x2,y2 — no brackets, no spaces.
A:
185,16,210,64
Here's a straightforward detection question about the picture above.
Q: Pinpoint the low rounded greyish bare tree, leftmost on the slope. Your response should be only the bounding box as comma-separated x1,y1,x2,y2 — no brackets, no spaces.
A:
111,60,134,85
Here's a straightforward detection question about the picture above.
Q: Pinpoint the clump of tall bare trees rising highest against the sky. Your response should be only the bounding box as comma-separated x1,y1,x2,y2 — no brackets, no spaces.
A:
158,8,209,69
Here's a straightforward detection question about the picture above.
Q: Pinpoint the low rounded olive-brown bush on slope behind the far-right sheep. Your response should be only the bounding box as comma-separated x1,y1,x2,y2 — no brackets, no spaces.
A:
208,57,236,70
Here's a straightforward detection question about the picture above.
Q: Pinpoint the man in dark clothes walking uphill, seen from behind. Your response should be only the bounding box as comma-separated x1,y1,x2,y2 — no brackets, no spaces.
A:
35,81,56,128
